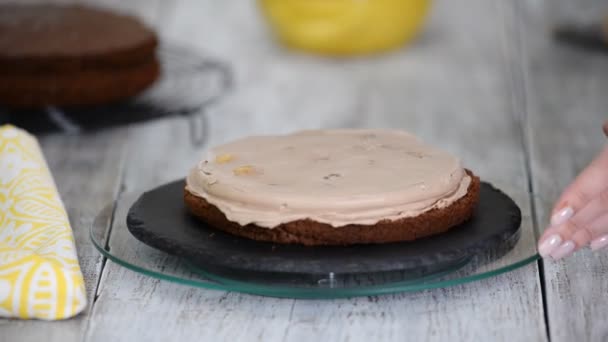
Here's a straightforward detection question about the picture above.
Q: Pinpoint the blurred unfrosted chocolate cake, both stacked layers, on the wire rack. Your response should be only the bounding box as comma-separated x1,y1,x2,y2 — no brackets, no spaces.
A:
0,3,160,108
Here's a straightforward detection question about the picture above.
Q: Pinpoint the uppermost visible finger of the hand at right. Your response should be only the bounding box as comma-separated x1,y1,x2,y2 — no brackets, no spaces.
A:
551,147,608,226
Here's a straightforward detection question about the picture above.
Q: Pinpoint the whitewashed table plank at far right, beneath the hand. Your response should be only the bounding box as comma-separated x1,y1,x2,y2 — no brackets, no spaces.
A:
522,0,608,342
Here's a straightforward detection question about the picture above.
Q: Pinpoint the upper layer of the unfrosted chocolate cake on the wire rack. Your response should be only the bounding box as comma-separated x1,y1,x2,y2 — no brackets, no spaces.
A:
0,3,158,74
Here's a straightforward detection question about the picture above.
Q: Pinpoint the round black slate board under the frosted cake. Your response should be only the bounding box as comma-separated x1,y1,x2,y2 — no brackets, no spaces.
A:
127,180,521,284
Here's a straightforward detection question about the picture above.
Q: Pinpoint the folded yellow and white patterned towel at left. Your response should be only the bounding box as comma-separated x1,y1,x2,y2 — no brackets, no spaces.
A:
0,126,86,320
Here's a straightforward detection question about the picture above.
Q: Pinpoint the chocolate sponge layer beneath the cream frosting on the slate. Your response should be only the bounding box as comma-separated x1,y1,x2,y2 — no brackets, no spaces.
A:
184,171,480,246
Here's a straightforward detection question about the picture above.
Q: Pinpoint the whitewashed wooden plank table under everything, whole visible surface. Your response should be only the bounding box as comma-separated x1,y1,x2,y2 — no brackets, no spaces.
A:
0,0,608,342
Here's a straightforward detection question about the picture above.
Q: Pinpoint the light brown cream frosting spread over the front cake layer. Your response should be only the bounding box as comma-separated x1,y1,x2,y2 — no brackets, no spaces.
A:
186,130,471,228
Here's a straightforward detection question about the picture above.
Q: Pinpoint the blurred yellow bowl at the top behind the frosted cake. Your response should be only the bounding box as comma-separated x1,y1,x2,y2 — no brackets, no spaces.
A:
258,0,430,56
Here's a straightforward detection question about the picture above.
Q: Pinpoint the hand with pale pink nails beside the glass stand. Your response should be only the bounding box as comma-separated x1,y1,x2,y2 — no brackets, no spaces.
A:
538,122,608,260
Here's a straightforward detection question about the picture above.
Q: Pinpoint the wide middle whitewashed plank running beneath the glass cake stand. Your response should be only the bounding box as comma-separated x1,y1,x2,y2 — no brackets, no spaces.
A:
86,0,546,341
